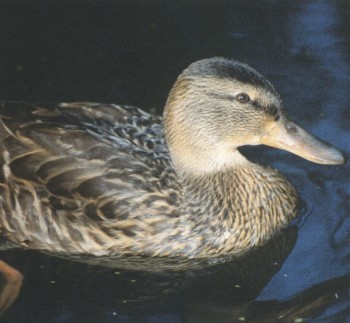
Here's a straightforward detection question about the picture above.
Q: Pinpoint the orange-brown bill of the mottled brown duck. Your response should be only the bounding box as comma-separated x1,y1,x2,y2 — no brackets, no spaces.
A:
260,116,345,165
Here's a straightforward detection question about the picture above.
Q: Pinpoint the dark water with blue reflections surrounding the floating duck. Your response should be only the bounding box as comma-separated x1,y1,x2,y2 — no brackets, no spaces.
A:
0,0,350,322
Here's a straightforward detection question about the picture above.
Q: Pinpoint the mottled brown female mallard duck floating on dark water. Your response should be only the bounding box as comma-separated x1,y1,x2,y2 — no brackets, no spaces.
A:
0,58,344,258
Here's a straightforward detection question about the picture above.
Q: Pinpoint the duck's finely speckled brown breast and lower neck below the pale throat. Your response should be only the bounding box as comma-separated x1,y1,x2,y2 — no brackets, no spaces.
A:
176,160,298,254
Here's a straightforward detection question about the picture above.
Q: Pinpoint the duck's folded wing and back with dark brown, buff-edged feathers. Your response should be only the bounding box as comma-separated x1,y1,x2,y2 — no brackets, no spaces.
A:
0,102,180,254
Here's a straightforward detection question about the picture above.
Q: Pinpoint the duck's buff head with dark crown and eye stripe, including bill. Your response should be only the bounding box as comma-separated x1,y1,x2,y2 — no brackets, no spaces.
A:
164,58,344,173
